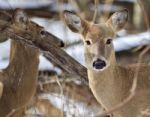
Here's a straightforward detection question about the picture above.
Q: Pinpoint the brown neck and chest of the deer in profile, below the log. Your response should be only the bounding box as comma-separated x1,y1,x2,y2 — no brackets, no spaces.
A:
0,40,39,116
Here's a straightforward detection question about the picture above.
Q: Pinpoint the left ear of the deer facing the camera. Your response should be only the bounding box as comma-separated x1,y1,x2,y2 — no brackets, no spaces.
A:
64,11,87,33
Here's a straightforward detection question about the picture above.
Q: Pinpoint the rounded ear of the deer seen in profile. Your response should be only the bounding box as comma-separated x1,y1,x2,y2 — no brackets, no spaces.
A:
13,9,28,24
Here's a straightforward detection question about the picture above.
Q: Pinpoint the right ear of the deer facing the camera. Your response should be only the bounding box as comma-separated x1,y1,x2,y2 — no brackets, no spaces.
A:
107,9,128,31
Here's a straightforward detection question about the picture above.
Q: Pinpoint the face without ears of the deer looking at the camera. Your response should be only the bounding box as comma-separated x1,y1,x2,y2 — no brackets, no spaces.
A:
84,24,114,71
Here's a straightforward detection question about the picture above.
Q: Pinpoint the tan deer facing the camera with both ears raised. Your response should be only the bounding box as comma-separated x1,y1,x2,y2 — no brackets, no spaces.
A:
63,9,150,117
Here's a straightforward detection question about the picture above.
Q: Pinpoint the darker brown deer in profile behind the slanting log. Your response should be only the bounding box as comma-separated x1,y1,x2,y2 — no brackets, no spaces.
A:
0,9,62,117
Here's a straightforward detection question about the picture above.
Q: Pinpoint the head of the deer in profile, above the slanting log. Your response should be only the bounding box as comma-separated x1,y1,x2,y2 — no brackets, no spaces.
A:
11,9,64,47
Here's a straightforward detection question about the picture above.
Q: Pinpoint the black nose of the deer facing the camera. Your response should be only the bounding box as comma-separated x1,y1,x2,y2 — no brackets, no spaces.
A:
93,59,106,69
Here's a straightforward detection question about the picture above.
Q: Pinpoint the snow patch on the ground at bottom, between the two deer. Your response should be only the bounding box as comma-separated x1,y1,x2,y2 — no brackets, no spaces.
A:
39,93,102,117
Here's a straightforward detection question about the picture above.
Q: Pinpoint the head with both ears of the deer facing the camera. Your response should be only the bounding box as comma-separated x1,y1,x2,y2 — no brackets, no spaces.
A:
64,9,128,71
